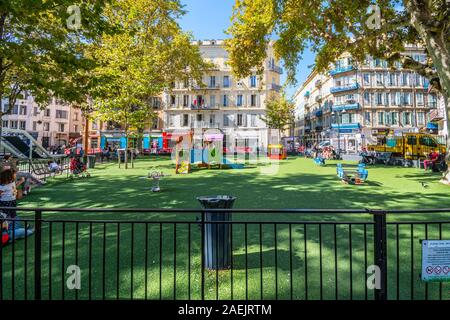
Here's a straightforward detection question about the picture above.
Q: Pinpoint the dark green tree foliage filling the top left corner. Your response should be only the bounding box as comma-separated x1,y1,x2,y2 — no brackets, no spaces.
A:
0,0,114,116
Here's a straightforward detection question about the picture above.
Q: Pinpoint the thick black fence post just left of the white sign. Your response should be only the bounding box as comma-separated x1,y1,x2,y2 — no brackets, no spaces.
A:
372,211,387,300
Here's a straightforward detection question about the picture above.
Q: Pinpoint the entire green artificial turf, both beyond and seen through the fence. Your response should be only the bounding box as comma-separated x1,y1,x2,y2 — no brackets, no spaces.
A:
0,158,450,299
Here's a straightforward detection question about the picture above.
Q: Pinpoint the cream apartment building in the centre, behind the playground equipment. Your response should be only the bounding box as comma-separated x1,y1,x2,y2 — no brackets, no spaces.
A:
163,40,282,149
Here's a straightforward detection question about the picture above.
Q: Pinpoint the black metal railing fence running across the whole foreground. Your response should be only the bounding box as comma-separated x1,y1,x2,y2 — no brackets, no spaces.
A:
0,208,450,300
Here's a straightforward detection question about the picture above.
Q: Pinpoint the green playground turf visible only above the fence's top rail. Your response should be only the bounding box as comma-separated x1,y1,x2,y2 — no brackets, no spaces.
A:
20,156,450,209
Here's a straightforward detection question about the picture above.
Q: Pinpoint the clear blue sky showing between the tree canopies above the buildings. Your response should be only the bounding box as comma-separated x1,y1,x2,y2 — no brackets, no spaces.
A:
180,0,314,97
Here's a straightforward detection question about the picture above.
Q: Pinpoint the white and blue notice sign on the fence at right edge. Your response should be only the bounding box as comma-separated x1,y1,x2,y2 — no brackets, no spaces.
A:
421,240,450,282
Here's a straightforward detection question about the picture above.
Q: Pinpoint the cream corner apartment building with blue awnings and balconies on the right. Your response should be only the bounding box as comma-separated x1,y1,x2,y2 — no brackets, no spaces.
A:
294,46,439,152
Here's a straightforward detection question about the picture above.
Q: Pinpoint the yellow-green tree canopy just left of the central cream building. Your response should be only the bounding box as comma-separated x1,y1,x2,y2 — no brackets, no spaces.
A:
88,0,211,166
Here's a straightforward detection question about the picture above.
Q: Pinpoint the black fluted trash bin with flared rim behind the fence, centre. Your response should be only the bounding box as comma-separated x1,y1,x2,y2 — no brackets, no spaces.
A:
197,195,236,270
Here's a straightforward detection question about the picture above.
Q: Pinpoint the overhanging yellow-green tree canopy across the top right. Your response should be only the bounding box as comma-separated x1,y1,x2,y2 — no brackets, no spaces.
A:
227,0,450,97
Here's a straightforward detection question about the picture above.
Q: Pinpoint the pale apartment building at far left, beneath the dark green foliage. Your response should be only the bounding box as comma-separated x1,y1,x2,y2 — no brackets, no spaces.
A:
2,93,81,148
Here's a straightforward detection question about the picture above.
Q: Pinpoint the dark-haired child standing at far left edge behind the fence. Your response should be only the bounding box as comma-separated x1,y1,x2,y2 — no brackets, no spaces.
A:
0,169,34,242
